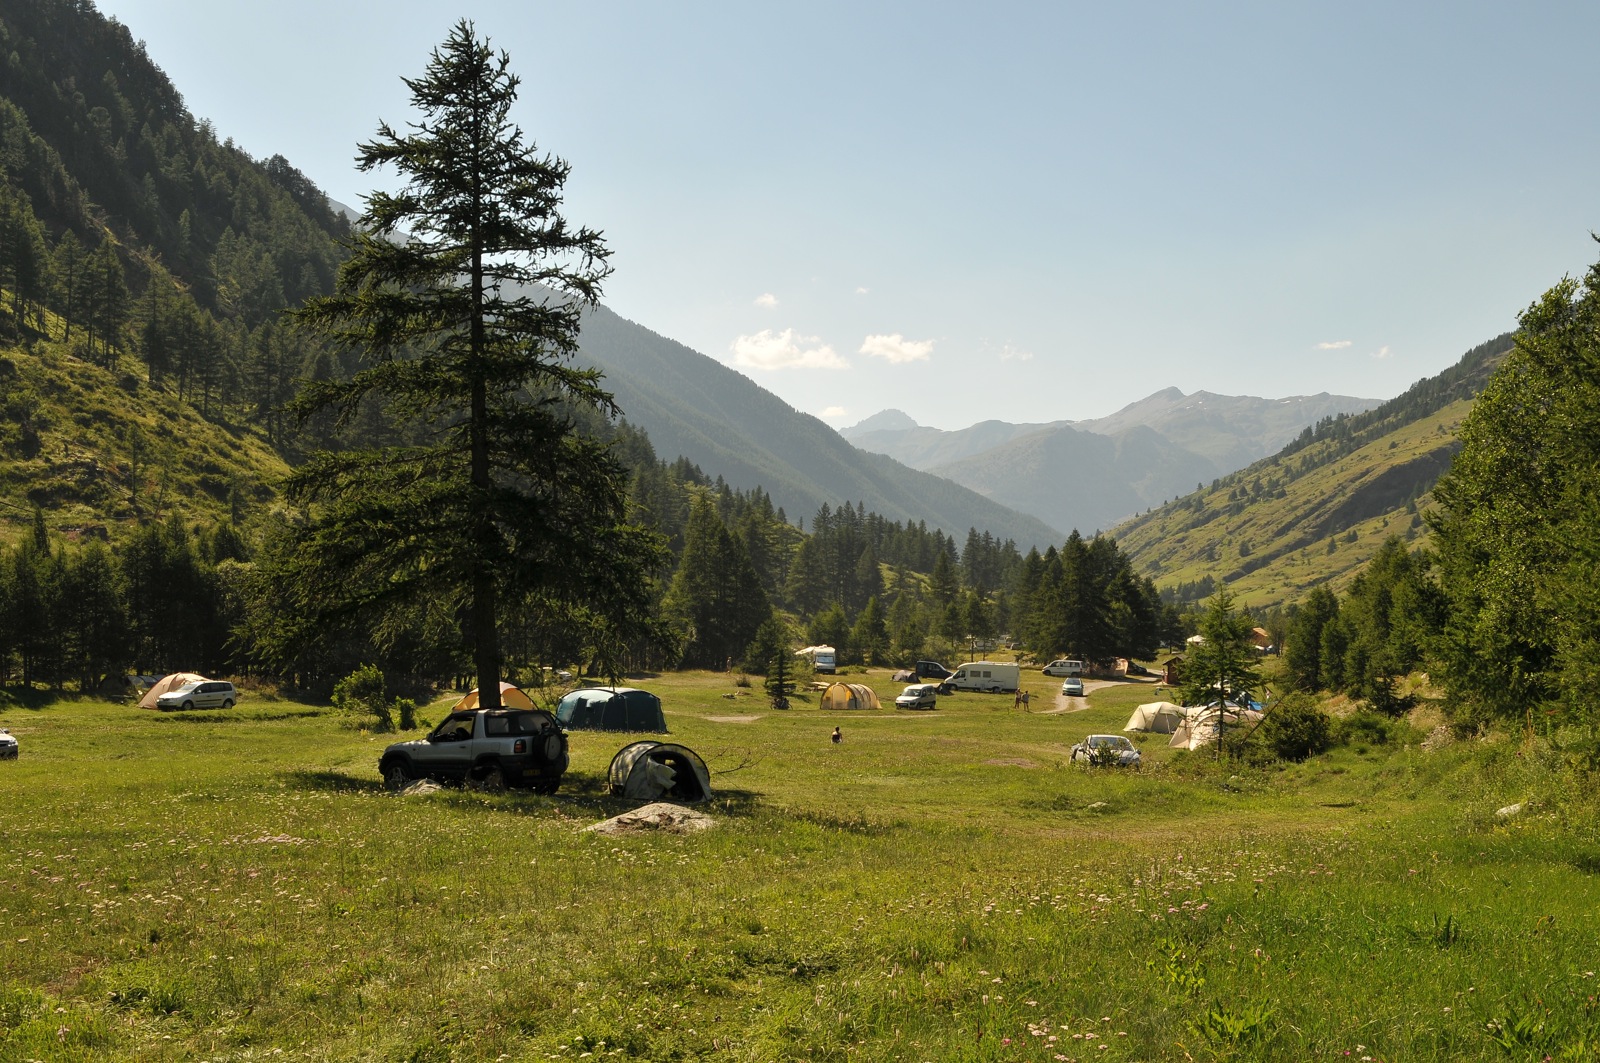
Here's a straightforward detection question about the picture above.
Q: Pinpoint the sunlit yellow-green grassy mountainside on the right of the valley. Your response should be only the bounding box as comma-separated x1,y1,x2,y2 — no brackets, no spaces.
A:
1114,333,1510,607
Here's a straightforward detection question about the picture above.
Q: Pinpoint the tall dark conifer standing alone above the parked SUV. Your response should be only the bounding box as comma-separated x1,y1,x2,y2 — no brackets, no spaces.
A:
286,19,662,708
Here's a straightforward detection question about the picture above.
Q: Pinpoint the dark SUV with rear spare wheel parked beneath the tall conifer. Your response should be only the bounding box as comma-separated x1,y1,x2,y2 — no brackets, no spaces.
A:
378,709,570,794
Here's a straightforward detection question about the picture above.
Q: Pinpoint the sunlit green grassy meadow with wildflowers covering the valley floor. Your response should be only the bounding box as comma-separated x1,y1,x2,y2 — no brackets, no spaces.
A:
0,672,1600,1061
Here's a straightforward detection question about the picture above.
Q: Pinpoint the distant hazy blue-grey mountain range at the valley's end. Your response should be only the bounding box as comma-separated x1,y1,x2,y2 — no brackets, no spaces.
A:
840,387,1381,533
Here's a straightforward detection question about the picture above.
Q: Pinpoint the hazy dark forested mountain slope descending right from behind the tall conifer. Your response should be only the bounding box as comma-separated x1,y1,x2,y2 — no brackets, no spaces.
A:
581,300,1064,549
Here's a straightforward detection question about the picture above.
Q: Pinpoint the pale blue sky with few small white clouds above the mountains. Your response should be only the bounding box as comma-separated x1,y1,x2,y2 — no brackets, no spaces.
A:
99,0,1600,429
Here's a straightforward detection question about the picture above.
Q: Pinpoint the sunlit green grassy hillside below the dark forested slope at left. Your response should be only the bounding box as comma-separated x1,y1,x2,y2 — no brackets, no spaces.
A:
0,328,286,541
